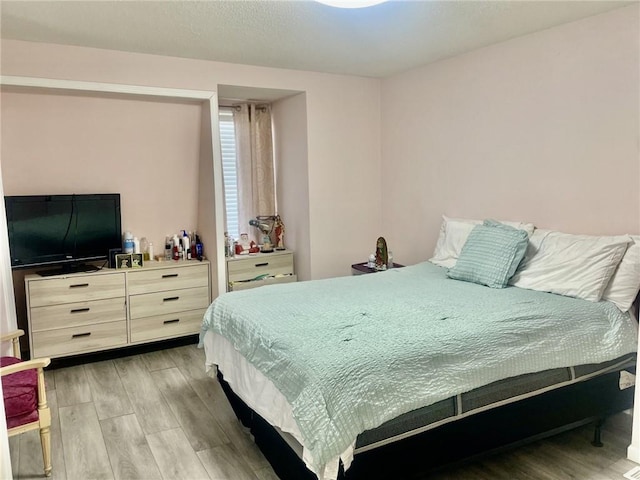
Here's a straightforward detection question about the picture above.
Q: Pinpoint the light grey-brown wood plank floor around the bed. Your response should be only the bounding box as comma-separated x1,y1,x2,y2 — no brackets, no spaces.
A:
9,345,636,480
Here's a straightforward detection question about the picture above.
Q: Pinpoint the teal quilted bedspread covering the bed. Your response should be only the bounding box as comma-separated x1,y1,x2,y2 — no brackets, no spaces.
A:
203,262,638,474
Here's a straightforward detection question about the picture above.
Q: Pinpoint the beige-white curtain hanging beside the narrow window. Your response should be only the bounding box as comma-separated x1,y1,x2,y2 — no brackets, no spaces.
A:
233,104,276,243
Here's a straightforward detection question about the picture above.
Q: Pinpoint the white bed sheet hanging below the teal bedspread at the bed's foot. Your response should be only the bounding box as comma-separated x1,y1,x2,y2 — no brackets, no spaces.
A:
203,330,355,480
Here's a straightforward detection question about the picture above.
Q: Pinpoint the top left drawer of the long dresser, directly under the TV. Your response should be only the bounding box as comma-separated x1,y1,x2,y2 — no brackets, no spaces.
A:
28,273,125,308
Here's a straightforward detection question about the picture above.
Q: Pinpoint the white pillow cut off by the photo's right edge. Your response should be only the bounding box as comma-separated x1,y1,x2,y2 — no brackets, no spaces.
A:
602,235,640,312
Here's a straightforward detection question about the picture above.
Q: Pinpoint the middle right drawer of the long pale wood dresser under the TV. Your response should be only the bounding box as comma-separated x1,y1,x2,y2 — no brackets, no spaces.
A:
129,287,209,320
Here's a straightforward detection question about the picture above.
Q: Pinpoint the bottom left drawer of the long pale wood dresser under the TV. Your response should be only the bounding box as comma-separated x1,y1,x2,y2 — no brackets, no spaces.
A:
31,320,127,357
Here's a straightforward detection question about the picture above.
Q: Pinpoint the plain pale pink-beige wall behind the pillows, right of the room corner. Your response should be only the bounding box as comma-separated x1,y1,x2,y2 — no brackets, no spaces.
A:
382,5,640,263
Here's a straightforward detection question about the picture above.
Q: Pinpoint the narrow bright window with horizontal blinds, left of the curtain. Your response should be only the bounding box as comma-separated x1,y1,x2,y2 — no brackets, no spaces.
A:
219,107,240,239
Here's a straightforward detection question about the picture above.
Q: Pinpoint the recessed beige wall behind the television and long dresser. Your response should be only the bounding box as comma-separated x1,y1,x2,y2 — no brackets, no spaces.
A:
1,92,202,253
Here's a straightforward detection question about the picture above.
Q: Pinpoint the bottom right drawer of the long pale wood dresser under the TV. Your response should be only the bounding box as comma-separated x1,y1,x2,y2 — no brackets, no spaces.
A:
131,308,206,342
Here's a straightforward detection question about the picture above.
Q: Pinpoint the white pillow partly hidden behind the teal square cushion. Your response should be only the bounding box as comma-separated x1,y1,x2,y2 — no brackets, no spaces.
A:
429,215,535,268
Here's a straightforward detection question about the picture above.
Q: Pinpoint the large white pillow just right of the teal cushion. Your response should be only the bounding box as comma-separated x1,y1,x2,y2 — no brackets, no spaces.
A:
509,230,631,302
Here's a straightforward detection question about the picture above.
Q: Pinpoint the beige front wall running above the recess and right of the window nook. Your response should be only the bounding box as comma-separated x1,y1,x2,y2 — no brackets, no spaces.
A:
1,41,380,284
